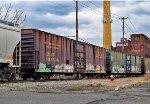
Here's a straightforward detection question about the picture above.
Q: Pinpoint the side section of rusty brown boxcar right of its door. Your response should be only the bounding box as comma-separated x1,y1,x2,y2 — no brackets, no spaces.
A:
86,44,105,73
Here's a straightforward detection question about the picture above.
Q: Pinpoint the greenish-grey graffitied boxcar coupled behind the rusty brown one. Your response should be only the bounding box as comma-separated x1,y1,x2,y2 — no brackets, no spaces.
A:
106,51,144,75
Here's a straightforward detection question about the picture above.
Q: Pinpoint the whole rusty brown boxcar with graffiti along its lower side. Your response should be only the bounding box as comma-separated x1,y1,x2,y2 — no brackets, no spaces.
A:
21,29,105,79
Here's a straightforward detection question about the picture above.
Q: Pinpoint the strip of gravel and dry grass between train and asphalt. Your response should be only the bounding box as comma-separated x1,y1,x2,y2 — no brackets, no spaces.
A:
0,74,150,93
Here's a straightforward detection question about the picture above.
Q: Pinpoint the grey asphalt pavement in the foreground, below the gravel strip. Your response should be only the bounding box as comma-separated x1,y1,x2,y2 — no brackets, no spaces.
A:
0,83,150,104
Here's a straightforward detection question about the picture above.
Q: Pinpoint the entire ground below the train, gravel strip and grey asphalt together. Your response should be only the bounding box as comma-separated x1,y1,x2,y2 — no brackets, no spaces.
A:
0,74,150,104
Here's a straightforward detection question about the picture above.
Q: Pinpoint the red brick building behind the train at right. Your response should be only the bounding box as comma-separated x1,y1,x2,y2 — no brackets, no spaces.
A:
115,34,150,57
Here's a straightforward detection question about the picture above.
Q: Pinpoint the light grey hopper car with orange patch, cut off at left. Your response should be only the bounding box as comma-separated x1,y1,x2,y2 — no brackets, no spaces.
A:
0,23,21,80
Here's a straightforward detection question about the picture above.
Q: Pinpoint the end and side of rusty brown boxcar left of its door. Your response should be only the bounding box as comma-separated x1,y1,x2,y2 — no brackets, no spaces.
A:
22,29,74,72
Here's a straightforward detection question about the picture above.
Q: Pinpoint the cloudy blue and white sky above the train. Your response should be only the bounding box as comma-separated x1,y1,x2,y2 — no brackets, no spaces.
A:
0,0,150,46
